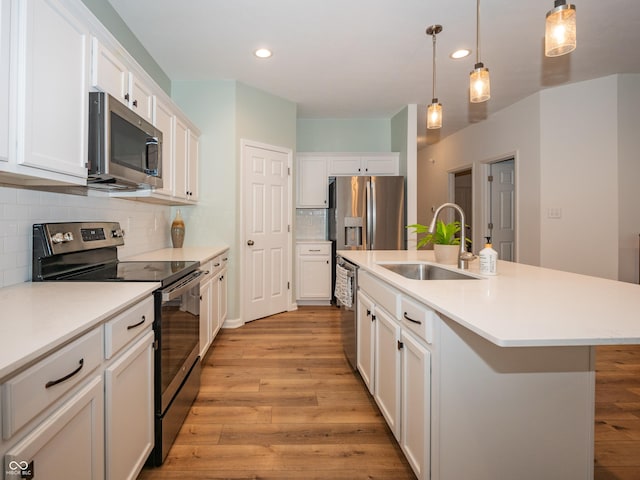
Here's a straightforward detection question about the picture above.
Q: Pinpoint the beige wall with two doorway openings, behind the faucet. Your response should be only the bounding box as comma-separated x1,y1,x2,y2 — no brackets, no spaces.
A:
418,95,540,265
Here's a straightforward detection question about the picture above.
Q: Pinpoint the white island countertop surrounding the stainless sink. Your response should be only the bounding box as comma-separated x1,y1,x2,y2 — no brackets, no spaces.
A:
338,250,640,347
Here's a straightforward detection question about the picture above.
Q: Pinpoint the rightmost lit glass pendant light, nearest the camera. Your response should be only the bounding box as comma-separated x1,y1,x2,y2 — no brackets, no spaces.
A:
544,0,576,57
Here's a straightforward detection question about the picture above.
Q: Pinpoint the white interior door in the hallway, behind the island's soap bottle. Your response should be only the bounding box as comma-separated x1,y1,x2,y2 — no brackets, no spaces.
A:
489,159,516,262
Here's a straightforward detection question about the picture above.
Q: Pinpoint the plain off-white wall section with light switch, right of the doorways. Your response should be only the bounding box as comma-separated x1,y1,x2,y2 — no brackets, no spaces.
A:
540,76,620,279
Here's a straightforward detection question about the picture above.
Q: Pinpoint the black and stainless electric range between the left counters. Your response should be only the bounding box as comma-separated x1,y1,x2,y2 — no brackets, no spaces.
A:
32,222,205,465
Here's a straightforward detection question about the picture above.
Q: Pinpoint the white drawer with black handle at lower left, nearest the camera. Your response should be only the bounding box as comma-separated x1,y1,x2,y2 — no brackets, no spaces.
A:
2,328,103,439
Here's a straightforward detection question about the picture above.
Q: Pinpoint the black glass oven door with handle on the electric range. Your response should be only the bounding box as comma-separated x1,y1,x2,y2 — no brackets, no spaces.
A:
154,270,204,415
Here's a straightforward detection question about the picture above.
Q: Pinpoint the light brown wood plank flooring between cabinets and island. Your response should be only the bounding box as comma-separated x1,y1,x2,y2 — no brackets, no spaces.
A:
138,307,640,480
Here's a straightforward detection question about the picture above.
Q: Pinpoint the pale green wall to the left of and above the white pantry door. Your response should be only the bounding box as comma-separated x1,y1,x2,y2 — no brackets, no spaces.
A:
171,80,296,320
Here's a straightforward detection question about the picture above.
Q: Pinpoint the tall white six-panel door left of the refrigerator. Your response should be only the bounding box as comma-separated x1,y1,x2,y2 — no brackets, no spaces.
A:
241,144,291,322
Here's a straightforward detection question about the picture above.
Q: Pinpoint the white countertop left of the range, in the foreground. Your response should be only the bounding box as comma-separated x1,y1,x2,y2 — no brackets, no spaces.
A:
0,282,160,383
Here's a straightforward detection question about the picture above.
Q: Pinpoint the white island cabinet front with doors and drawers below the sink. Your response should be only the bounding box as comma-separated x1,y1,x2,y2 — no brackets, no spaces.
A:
357,272,435,480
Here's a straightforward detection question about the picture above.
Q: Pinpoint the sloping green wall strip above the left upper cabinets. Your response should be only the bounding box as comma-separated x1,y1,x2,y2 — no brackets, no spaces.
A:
79,0,171,93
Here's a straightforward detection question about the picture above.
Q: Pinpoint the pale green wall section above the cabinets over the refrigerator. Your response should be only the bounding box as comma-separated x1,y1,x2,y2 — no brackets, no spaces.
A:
297,118,391,152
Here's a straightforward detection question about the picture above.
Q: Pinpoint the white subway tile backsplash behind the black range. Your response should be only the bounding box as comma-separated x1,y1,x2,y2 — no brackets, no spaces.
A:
0,186,172,287
